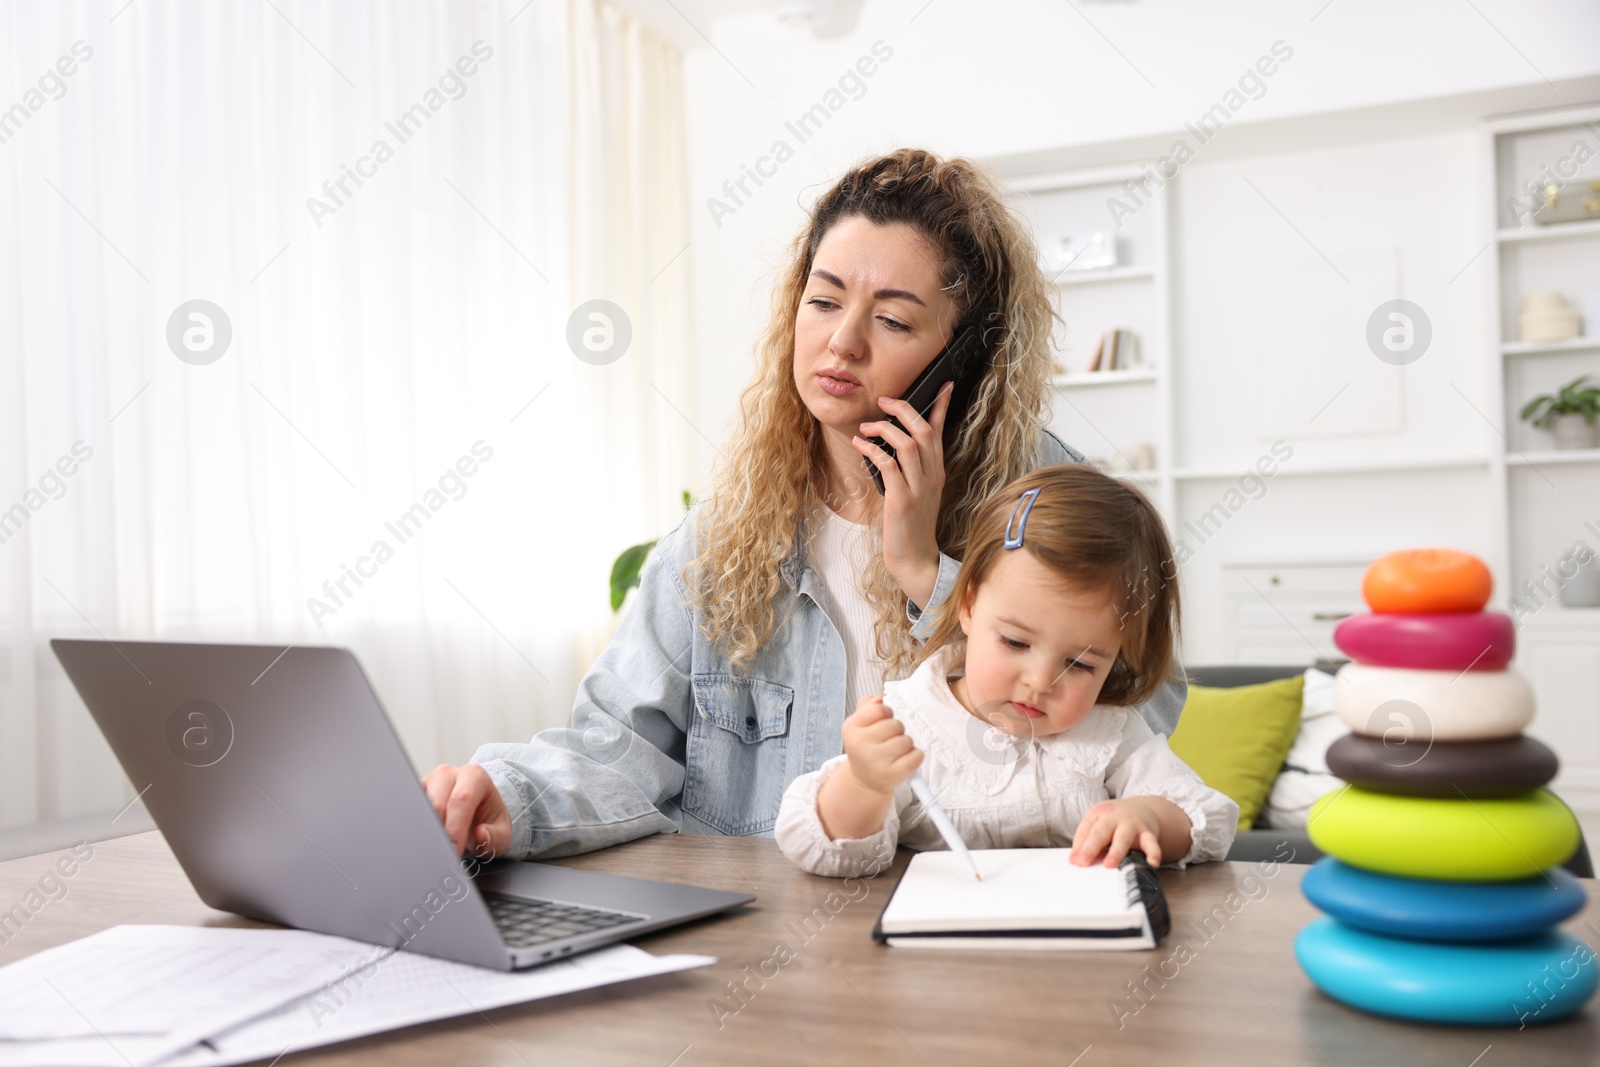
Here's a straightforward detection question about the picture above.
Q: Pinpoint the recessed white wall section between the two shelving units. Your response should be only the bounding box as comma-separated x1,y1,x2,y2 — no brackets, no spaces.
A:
1173,133,1493,662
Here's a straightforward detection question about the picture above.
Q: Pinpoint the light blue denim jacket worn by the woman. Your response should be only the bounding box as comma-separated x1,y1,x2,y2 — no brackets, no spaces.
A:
472,430,1187,859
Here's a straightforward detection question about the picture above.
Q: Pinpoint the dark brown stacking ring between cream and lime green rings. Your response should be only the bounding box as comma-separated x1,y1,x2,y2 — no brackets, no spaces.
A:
1326,734,1558,800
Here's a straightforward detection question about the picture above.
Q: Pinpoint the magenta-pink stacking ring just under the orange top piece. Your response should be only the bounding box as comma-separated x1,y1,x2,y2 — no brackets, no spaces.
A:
1333,611,1517,670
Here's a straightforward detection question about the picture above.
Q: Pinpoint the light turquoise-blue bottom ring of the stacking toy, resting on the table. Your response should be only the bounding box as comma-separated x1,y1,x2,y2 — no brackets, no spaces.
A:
1294,915,1600,1027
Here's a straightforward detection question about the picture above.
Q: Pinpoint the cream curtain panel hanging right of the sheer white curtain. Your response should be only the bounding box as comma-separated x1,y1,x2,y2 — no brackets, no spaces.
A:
566,0,698,662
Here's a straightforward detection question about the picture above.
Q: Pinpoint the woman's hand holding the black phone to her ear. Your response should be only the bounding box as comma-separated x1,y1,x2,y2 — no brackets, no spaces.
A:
853,382,955,606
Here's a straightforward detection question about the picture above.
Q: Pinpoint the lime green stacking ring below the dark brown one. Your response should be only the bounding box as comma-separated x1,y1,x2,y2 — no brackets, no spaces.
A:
1306,785,1579,881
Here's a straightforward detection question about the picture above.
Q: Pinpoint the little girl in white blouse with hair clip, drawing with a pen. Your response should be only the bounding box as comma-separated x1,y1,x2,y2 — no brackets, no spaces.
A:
776,464,1238,877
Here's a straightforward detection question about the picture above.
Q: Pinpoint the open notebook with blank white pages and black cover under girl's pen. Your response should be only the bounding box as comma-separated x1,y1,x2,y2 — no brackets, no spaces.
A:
872,848,1171,950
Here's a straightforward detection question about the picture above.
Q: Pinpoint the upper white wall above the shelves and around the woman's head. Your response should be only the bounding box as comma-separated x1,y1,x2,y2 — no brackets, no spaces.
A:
685,0,1600,464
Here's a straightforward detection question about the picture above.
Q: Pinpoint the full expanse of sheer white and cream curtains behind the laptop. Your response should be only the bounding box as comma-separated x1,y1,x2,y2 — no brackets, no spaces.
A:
0,0,690,827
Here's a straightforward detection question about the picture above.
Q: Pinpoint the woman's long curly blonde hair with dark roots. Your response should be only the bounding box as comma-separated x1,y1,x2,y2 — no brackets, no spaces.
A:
683,149,1059,684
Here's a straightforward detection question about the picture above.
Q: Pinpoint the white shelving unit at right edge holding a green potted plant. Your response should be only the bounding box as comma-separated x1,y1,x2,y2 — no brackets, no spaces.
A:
1482,106,1600,813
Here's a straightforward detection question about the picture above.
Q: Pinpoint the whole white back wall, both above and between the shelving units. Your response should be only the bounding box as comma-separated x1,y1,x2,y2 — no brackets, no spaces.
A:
672,0,1600,662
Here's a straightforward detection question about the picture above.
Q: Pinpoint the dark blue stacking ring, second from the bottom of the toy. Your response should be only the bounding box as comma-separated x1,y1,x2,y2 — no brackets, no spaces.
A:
1301,856,1586,942
